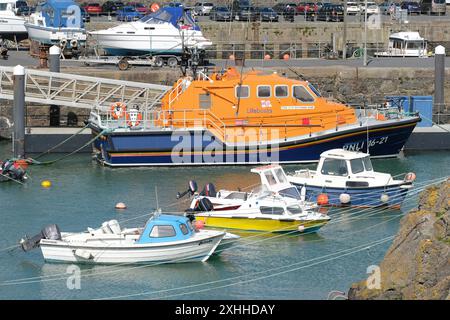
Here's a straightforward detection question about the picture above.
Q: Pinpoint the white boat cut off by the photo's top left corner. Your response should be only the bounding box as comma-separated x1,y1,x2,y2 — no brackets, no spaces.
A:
0,0,28,42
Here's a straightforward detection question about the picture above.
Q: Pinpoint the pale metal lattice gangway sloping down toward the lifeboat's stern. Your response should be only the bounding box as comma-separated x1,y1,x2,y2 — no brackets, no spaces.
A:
0,67,170,110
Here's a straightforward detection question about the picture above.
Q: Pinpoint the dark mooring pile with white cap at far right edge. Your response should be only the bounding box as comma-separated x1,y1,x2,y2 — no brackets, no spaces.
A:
433,46,445,124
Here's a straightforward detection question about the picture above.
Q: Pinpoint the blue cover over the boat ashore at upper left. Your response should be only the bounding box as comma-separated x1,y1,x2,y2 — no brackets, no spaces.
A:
36,0,84,28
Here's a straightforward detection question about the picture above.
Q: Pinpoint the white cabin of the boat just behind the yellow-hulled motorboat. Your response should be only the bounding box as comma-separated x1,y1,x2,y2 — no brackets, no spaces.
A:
251,165,301,200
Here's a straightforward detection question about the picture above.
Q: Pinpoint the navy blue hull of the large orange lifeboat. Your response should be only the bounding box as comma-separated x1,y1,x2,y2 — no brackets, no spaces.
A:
91,118,419,166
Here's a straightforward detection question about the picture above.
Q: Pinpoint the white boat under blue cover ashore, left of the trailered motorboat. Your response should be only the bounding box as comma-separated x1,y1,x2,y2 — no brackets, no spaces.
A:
25,0,86,50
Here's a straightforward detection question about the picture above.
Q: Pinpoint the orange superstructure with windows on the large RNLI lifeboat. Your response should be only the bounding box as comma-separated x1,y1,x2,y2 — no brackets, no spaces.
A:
158,68,357,142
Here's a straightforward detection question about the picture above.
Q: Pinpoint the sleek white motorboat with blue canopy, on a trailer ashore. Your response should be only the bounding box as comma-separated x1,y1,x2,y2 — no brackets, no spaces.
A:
88,7,211,56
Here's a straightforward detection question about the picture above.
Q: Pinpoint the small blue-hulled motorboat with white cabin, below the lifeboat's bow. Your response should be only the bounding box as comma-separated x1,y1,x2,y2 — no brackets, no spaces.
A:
288,149,415,208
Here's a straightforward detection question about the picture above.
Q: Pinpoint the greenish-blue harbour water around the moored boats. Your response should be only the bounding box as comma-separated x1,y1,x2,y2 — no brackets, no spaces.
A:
0,142,450,299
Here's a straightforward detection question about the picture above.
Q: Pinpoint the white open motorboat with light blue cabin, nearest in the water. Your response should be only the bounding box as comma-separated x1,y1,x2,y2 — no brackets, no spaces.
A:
20,213,229,264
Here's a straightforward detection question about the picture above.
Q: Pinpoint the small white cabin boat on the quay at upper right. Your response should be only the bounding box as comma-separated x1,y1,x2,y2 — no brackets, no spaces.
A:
375,31,428,58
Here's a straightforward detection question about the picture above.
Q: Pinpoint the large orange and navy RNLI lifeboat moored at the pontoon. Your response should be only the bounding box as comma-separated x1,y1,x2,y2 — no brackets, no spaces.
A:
88,67,420,167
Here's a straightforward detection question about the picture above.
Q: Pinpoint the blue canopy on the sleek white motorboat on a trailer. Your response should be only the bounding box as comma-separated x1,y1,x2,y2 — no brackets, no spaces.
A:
139,7,200,31
